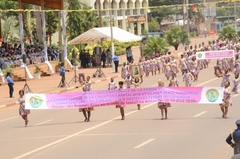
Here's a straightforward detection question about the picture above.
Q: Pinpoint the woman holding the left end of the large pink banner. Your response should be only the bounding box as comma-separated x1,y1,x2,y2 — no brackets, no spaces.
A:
18,90,30,126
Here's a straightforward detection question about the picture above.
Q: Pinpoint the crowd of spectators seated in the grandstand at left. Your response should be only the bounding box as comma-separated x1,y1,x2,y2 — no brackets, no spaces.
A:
0,42,61,69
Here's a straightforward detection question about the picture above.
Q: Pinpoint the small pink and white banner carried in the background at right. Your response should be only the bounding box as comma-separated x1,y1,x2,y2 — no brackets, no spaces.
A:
196,50,234,59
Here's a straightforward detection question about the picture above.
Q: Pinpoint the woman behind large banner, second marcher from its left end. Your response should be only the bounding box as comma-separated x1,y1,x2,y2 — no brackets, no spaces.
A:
79,76,94,122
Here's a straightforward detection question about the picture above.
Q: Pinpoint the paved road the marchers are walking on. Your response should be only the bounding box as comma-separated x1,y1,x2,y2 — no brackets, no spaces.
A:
0,58,240,159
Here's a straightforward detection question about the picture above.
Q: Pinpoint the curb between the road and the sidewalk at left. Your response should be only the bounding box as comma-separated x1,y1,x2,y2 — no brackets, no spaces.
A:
0,75,121,109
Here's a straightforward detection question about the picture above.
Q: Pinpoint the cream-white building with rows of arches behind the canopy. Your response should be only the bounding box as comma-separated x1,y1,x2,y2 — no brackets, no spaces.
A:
81,0,149,35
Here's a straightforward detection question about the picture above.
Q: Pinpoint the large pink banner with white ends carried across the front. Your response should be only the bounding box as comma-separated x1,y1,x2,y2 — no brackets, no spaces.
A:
25,87,223,109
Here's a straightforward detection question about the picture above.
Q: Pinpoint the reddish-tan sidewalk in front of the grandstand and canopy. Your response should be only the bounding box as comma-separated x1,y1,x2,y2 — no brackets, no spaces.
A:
0,67,120,108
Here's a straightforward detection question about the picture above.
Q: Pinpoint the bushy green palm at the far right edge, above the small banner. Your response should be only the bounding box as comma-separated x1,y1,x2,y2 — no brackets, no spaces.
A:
219,25,238,41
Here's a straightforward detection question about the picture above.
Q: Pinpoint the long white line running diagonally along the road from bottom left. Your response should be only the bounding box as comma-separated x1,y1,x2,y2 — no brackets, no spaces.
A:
14,103,156,159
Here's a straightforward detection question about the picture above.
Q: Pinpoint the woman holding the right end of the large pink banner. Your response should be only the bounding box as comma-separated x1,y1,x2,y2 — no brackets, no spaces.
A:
219,81,232,118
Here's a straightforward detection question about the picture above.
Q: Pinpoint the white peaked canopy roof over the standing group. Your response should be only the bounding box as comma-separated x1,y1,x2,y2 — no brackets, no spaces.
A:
68,27,142,45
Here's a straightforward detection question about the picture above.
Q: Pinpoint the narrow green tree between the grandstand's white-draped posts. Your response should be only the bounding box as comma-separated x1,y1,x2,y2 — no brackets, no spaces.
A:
45,12,58,45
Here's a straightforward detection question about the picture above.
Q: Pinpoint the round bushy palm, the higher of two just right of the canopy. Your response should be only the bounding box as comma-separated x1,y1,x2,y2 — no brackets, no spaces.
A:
165,27,190,50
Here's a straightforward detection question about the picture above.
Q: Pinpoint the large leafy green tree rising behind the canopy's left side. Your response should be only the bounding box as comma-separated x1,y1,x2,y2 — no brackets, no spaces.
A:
67,0,98,40
